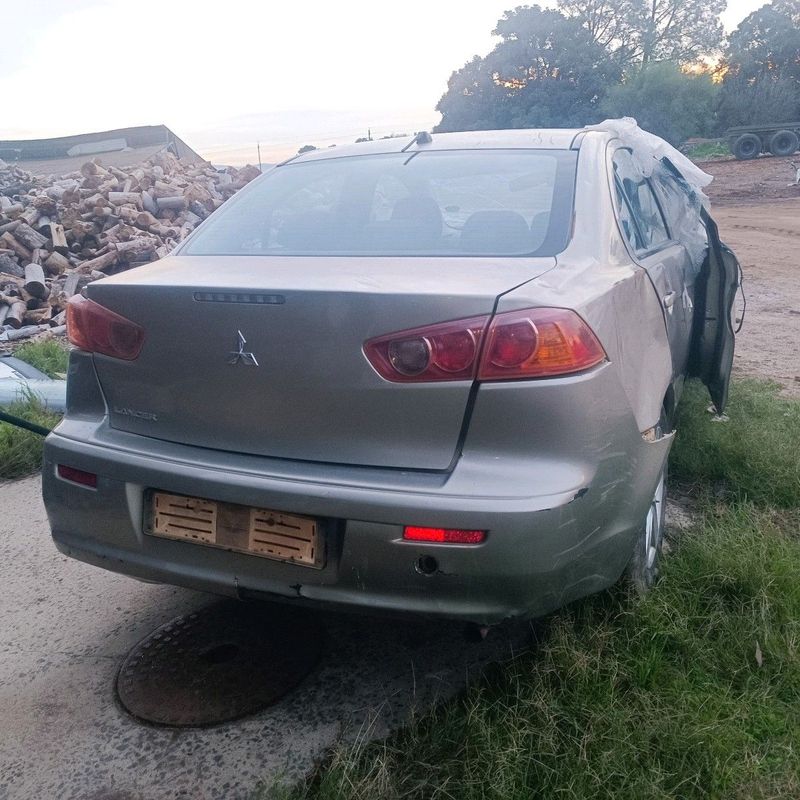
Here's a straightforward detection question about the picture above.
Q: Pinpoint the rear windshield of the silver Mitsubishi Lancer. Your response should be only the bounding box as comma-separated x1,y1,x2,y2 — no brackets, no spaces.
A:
181,150,577,256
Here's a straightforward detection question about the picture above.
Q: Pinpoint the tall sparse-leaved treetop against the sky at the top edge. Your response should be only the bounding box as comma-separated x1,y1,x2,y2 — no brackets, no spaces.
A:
558,0,727,65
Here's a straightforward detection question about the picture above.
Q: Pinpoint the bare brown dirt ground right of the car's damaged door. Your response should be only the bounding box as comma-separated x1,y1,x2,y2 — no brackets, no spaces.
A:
700,158,800,397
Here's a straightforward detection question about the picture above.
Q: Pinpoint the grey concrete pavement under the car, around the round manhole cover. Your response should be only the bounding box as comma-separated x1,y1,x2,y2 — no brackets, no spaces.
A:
0,477,527,800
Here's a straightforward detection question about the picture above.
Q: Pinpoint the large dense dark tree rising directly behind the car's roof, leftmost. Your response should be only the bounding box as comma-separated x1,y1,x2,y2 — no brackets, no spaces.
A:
436,6,620,131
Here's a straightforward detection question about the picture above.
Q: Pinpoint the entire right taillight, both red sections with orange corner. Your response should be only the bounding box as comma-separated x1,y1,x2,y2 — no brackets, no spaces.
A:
364,308,606,383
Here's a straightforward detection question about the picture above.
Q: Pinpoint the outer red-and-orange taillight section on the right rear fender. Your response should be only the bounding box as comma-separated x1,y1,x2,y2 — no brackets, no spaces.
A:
478,308,606,381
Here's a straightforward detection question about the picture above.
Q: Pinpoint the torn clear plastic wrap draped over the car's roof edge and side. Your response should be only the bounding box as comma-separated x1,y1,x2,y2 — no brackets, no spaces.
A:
586,117,714,272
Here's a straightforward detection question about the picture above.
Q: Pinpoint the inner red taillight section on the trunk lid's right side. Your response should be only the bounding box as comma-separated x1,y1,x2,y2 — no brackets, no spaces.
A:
364,317,489,383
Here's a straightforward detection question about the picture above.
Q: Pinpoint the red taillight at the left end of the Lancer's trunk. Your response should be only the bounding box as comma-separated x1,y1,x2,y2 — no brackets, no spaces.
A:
67,295,144,361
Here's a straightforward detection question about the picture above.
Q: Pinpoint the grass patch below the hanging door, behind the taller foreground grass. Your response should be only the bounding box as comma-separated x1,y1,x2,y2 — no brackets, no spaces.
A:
670,379,800,508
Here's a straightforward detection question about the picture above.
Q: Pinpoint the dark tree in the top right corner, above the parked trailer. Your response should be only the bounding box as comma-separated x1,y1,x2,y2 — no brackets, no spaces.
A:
725,0,800,81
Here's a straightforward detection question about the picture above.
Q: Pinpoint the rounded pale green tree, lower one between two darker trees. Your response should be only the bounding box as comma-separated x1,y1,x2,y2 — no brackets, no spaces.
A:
601,61,717,146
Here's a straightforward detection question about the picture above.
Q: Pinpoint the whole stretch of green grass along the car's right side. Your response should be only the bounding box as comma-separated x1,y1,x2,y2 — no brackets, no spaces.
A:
268,380,800,800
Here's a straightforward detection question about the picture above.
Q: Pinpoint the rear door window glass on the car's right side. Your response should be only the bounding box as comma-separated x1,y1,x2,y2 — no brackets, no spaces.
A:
614,150,670,252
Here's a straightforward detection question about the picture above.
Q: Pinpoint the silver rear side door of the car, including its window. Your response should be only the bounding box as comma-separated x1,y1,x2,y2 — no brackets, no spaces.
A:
613,148,694,377
